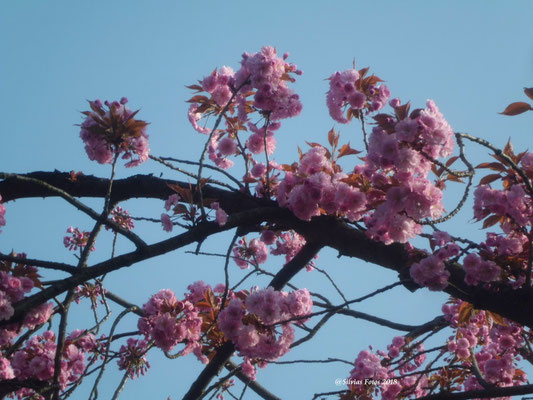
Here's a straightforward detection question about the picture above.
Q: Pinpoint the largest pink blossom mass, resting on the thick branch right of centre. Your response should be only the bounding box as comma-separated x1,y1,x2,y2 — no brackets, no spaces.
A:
276,97,453,244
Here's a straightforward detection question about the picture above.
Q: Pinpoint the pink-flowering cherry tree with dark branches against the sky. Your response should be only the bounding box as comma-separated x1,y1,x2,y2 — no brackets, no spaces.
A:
0,47,533,400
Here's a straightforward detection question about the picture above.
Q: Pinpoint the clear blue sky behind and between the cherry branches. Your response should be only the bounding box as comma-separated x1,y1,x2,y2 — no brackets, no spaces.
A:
0,0,533,399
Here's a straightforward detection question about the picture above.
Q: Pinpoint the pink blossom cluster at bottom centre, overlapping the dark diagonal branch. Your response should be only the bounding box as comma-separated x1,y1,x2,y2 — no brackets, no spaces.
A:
218,287,313,379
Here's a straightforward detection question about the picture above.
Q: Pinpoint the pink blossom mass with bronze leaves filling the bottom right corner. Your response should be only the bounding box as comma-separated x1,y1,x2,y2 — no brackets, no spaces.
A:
343,300,530,400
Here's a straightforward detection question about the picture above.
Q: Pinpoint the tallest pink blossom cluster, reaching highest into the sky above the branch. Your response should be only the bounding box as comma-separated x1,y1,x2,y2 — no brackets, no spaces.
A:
188,46,302,173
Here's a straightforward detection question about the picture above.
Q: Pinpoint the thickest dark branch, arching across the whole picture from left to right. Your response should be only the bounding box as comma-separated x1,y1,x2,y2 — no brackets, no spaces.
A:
0,172,533,328
